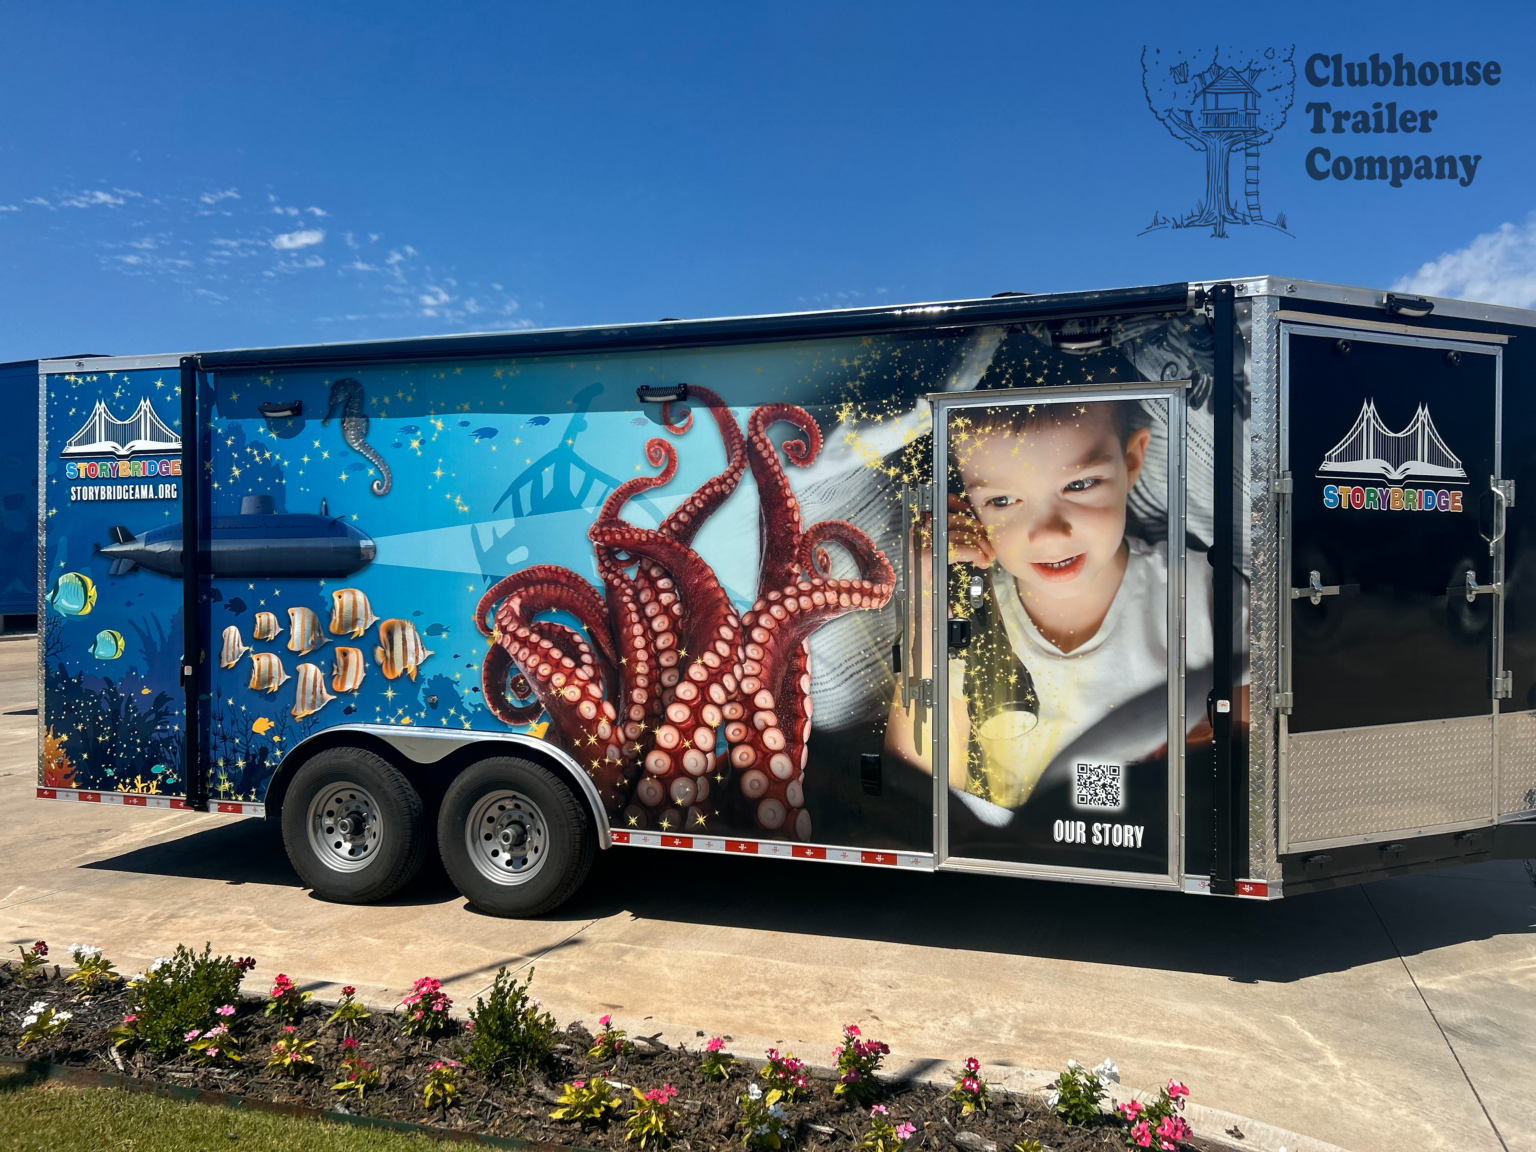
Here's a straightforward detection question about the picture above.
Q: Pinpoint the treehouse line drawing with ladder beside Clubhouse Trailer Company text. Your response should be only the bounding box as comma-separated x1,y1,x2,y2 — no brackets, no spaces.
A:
1138,45,1296,238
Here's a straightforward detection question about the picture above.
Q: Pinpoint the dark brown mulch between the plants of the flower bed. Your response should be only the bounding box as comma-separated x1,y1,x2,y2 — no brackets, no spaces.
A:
0,966,1220,1152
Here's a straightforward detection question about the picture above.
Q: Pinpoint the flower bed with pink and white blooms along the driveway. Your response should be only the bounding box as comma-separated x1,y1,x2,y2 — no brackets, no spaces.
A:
0,949,1201,1152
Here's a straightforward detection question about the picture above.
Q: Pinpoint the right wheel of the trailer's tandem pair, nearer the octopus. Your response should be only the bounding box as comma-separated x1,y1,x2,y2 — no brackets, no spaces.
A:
438,756,596,917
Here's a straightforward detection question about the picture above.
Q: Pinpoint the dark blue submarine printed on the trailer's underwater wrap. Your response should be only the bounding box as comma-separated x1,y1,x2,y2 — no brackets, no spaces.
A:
100,496,378,578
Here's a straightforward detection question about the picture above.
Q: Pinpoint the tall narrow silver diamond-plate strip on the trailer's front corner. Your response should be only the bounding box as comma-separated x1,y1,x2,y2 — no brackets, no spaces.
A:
1238,296,1279,880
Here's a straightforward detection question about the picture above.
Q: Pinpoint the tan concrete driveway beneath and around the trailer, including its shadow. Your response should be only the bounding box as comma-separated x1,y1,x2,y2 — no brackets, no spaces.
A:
0,644,1536,1152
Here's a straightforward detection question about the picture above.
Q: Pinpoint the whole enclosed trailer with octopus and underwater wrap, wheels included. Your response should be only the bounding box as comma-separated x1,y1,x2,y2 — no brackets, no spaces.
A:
38,278,1536,914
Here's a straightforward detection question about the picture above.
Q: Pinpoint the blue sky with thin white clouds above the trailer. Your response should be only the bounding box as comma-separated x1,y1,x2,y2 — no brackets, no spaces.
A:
0,0,1536,359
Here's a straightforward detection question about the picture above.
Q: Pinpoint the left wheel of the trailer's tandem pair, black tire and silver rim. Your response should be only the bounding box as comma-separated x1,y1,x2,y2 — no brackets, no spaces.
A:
283,748,430,905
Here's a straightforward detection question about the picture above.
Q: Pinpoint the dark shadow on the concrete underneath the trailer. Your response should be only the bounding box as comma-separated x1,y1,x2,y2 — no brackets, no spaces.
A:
84,820,1536,983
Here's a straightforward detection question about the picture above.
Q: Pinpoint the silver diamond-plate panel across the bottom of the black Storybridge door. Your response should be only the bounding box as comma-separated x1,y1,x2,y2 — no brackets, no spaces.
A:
1286,716,1493,848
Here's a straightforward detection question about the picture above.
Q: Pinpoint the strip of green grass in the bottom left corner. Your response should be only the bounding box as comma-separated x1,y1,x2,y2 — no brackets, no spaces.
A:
0,1074,448,1152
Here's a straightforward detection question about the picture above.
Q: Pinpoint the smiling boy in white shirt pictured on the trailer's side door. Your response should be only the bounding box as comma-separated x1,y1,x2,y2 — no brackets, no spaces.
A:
886,399,1212,826
